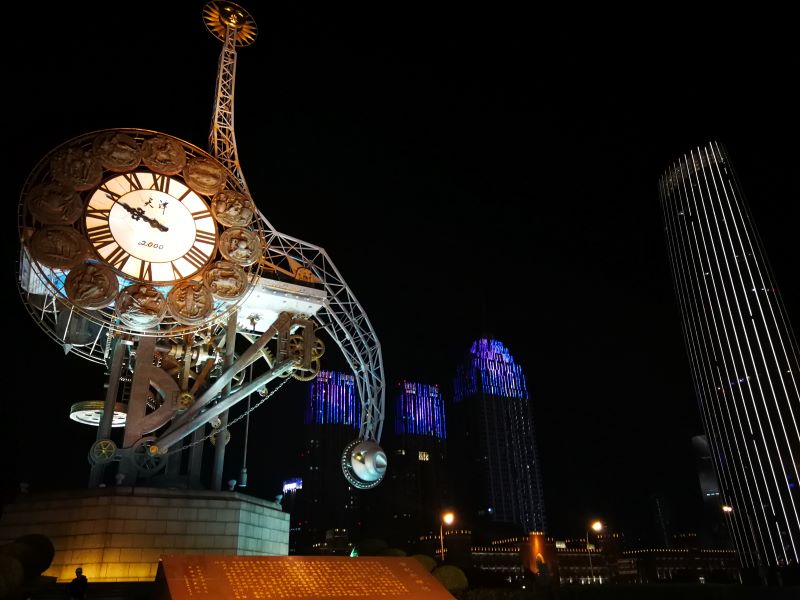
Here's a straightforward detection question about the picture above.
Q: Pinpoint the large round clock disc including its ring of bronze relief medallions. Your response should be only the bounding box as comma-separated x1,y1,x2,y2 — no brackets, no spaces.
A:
18,129,268,352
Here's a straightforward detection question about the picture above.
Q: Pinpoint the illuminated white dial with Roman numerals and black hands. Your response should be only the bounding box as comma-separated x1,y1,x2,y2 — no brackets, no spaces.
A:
85,171,218,283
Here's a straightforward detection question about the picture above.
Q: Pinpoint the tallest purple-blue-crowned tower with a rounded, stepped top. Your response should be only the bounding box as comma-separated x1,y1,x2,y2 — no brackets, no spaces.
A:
450,339,545,534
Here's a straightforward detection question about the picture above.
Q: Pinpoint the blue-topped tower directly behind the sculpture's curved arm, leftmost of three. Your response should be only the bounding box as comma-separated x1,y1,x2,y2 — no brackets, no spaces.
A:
290,371,360,554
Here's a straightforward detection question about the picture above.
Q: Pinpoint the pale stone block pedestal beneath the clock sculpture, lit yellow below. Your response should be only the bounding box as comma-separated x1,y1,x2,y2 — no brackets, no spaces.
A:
0,486,289,582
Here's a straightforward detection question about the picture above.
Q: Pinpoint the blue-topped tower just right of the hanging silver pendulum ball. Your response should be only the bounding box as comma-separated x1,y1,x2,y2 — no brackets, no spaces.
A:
372,381,449,548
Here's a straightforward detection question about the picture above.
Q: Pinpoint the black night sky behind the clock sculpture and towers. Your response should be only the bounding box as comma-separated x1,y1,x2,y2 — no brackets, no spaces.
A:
3,2,800,534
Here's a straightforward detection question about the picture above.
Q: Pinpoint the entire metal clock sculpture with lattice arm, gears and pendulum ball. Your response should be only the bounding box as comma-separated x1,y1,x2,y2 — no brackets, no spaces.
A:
18,1,386,489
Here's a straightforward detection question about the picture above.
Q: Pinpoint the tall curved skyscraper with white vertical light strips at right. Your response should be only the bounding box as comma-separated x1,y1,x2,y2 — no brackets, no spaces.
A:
659,142,800,569
